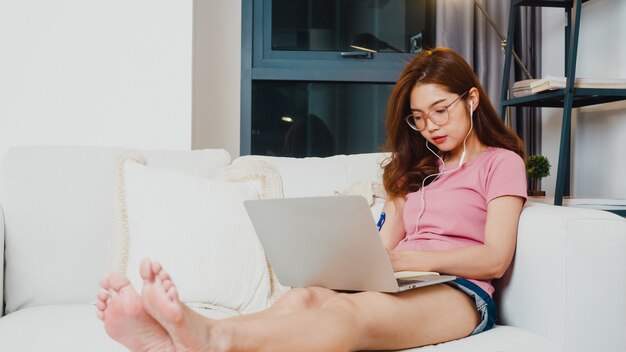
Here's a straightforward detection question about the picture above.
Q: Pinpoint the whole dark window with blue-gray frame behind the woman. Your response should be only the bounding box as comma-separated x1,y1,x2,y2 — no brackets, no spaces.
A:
241,0,435,156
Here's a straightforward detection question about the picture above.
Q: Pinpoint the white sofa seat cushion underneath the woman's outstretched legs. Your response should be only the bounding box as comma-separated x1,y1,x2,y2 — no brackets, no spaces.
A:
0,304,561,352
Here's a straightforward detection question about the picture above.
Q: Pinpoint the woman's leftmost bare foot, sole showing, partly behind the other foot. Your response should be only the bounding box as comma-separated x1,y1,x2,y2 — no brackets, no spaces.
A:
96,273,176,352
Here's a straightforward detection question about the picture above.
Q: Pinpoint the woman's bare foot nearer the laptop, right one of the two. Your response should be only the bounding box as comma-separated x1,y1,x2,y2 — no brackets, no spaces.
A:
141,259,228,352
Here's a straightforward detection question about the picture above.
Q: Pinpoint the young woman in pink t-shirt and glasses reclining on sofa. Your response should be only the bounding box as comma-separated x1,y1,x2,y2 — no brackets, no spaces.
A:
97,48,526,351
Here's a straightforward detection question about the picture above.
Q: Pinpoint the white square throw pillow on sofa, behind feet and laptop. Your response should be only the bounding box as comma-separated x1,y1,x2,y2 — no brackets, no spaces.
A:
121,160,271,313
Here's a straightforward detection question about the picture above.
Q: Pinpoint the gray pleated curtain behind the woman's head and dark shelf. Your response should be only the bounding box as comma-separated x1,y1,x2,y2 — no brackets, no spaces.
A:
436,0,541,155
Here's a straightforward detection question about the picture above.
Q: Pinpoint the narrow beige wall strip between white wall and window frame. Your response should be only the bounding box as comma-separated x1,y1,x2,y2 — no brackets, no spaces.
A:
192,0,241,157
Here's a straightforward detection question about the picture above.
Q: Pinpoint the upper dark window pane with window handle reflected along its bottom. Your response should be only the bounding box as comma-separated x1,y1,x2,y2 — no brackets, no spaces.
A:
272,0,435,53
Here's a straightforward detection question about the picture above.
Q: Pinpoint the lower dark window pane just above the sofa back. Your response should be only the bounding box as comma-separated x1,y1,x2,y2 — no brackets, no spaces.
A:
251,81,393,157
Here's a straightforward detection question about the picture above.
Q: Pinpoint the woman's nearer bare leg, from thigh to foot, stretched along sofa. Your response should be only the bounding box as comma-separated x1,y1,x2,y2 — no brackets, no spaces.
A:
142,258,478,352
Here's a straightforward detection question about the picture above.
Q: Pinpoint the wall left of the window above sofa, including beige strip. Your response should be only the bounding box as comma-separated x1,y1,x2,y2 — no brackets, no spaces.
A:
0,0,241,161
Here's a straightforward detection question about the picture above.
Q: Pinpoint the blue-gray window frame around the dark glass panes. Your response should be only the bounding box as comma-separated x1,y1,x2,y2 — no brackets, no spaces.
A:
240,0,435,155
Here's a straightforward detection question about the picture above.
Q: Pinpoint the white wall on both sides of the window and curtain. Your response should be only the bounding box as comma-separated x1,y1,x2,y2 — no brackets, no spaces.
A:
15,0,626,175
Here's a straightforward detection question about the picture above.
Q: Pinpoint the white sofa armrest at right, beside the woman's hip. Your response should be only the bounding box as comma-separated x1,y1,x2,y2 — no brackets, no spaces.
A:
496,202,626,351
